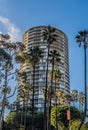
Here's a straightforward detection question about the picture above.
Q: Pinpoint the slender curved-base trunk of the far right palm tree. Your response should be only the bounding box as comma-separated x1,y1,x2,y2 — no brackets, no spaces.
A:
78,44,87,130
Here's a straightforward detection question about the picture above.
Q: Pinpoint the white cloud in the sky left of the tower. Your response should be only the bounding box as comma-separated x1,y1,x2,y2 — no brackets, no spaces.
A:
0,16,21,42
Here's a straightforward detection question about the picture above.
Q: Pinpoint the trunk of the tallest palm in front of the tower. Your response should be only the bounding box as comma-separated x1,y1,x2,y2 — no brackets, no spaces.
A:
43,43,50,130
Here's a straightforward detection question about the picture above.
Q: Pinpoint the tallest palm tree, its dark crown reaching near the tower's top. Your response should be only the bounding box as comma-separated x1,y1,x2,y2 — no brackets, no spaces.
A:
43,26,57,130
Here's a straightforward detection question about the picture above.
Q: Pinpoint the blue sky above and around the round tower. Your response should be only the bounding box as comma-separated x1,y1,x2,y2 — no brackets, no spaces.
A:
0,0,88,91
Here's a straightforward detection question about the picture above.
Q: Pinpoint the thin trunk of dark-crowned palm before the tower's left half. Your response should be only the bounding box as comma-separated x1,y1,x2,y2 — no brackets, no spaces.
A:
32,63,35,130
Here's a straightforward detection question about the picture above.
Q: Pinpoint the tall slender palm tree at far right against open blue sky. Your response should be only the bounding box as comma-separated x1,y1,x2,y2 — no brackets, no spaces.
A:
75,30,88,130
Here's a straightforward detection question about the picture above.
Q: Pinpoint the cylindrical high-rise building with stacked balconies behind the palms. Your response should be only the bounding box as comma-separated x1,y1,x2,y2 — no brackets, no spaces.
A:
20,26,70,111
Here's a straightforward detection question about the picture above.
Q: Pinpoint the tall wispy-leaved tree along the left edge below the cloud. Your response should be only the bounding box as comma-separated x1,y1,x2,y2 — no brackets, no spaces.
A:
0,34,19,130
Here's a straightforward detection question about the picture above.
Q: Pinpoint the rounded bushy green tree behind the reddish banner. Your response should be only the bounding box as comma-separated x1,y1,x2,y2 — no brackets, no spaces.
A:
51,106,81,130
